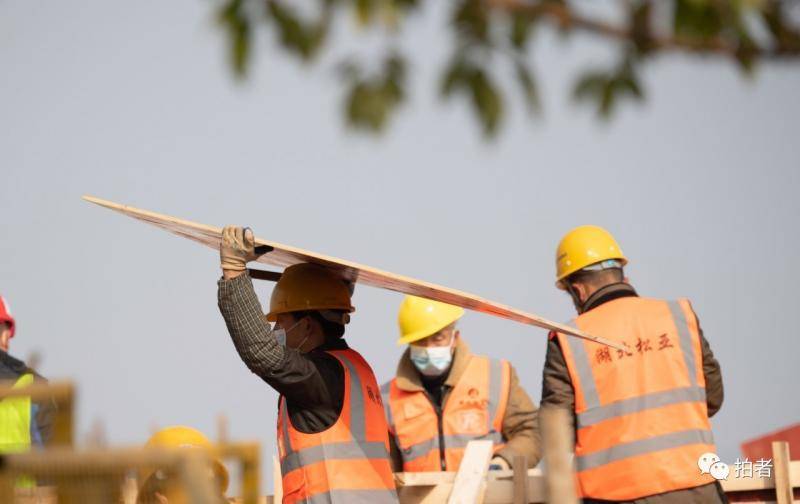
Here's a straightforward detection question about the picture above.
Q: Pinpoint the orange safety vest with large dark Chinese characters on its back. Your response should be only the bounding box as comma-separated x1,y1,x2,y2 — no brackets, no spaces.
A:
558,297,716,501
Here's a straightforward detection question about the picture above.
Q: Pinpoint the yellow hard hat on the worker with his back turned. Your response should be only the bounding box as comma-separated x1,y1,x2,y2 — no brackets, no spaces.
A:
556,226,628,289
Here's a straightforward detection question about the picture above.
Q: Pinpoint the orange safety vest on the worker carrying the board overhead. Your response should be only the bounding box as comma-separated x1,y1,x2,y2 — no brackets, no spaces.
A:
278,349,398,504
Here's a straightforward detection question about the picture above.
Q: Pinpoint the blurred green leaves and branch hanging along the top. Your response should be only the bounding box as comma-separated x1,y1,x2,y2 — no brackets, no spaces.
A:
217,0,800,138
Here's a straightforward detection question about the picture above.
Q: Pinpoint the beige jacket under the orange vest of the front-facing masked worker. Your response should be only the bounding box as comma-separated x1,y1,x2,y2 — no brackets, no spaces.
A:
389,338,542,471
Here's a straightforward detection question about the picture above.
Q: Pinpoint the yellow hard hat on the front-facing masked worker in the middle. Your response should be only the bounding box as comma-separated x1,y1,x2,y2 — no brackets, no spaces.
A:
397,296,464,345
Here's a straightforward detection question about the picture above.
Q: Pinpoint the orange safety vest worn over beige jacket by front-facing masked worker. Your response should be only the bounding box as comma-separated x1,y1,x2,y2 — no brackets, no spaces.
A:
381,355,511,472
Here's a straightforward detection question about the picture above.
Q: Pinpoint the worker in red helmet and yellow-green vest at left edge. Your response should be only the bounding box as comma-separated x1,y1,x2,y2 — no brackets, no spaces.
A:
0,296,55,454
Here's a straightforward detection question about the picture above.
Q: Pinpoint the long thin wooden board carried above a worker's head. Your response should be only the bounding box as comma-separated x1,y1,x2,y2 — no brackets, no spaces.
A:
83,196,625,351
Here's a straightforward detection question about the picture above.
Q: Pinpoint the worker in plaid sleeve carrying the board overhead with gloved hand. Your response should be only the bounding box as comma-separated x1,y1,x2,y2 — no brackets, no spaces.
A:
219,226,397,503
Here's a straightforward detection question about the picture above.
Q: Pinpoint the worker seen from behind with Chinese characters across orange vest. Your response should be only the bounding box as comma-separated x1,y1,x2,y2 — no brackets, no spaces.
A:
542,226,726,504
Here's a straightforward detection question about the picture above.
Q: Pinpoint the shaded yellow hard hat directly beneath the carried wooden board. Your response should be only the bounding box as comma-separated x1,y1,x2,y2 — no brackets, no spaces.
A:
267,263,356,322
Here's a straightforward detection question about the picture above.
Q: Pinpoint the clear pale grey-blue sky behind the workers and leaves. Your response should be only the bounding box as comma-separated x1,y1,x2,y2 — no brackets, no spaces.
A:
0,0,800,488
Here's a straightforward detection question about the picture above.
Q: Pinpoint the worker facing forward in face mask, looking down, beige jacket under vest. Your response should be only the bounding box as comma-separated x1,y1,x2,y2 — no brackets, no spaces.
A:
381,296,541,472
